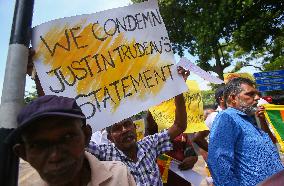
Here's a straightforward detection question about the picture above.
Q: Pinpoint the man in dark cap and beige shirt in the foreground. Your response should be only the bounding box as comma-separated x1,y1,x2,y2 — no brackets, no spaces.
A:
7,95,136,186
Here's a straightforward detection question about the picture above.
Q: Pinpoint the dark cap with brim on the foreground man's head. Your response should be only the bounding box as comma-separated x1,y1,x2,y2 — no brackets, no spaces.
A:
7,95,86,145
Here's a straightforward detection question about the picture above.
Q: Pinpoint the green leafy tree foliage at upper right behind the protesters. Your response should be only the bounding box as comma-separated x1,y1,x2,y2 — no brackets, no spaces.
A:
132,0,284,76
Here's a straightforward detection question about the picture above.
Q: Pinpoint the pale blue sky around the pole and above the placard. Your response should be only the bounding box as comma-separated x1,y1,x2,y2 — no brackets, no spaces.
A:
0,0,260,101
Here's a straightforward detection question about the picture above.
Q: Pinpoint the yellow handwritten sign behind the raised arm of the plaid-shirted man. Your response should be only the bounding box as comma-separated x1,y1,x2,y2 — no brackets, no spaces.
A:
149,80,208,133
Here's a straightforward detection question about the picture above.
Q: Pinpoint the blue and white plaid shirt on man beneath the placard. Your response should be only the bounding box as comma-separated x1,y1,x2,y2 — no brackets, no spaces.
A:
88,130,173,186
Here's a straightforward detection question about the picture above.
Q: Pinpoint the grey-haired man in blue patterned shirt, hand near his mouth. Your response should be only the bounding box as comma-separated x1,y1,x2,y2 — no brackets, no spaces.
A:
208,78,283,186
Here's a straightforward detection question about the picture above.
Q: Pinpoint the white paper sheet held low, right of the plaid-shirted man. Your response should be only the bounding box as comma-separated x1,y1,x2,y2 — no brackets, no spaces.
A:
170,160,203,186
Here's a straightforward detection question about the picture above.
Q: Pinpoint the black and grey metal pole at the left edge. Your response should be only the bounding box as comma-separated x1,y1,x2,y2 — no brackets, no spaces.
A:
0,0,34,186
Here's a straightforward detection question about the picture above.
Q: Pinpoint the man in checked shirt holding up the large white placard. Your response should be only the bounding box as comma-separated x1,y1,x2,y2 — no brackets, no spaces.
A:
88,94,187,186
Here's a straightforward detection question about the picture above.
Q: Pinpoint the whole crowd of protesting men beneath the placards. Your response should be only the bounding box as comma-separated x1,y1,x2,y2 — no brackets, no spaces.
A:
3,46,284,186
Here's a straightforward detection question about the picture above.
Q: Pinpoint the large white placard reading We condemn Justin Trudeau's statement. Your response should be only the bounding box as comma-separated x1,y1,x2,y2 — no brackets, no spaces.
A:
32,1,187,130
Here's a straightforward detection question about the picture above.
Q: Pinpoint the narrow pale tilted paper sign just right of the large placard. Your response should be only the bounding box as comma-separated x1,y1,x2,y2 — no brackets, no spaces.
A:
177,57,224,84
